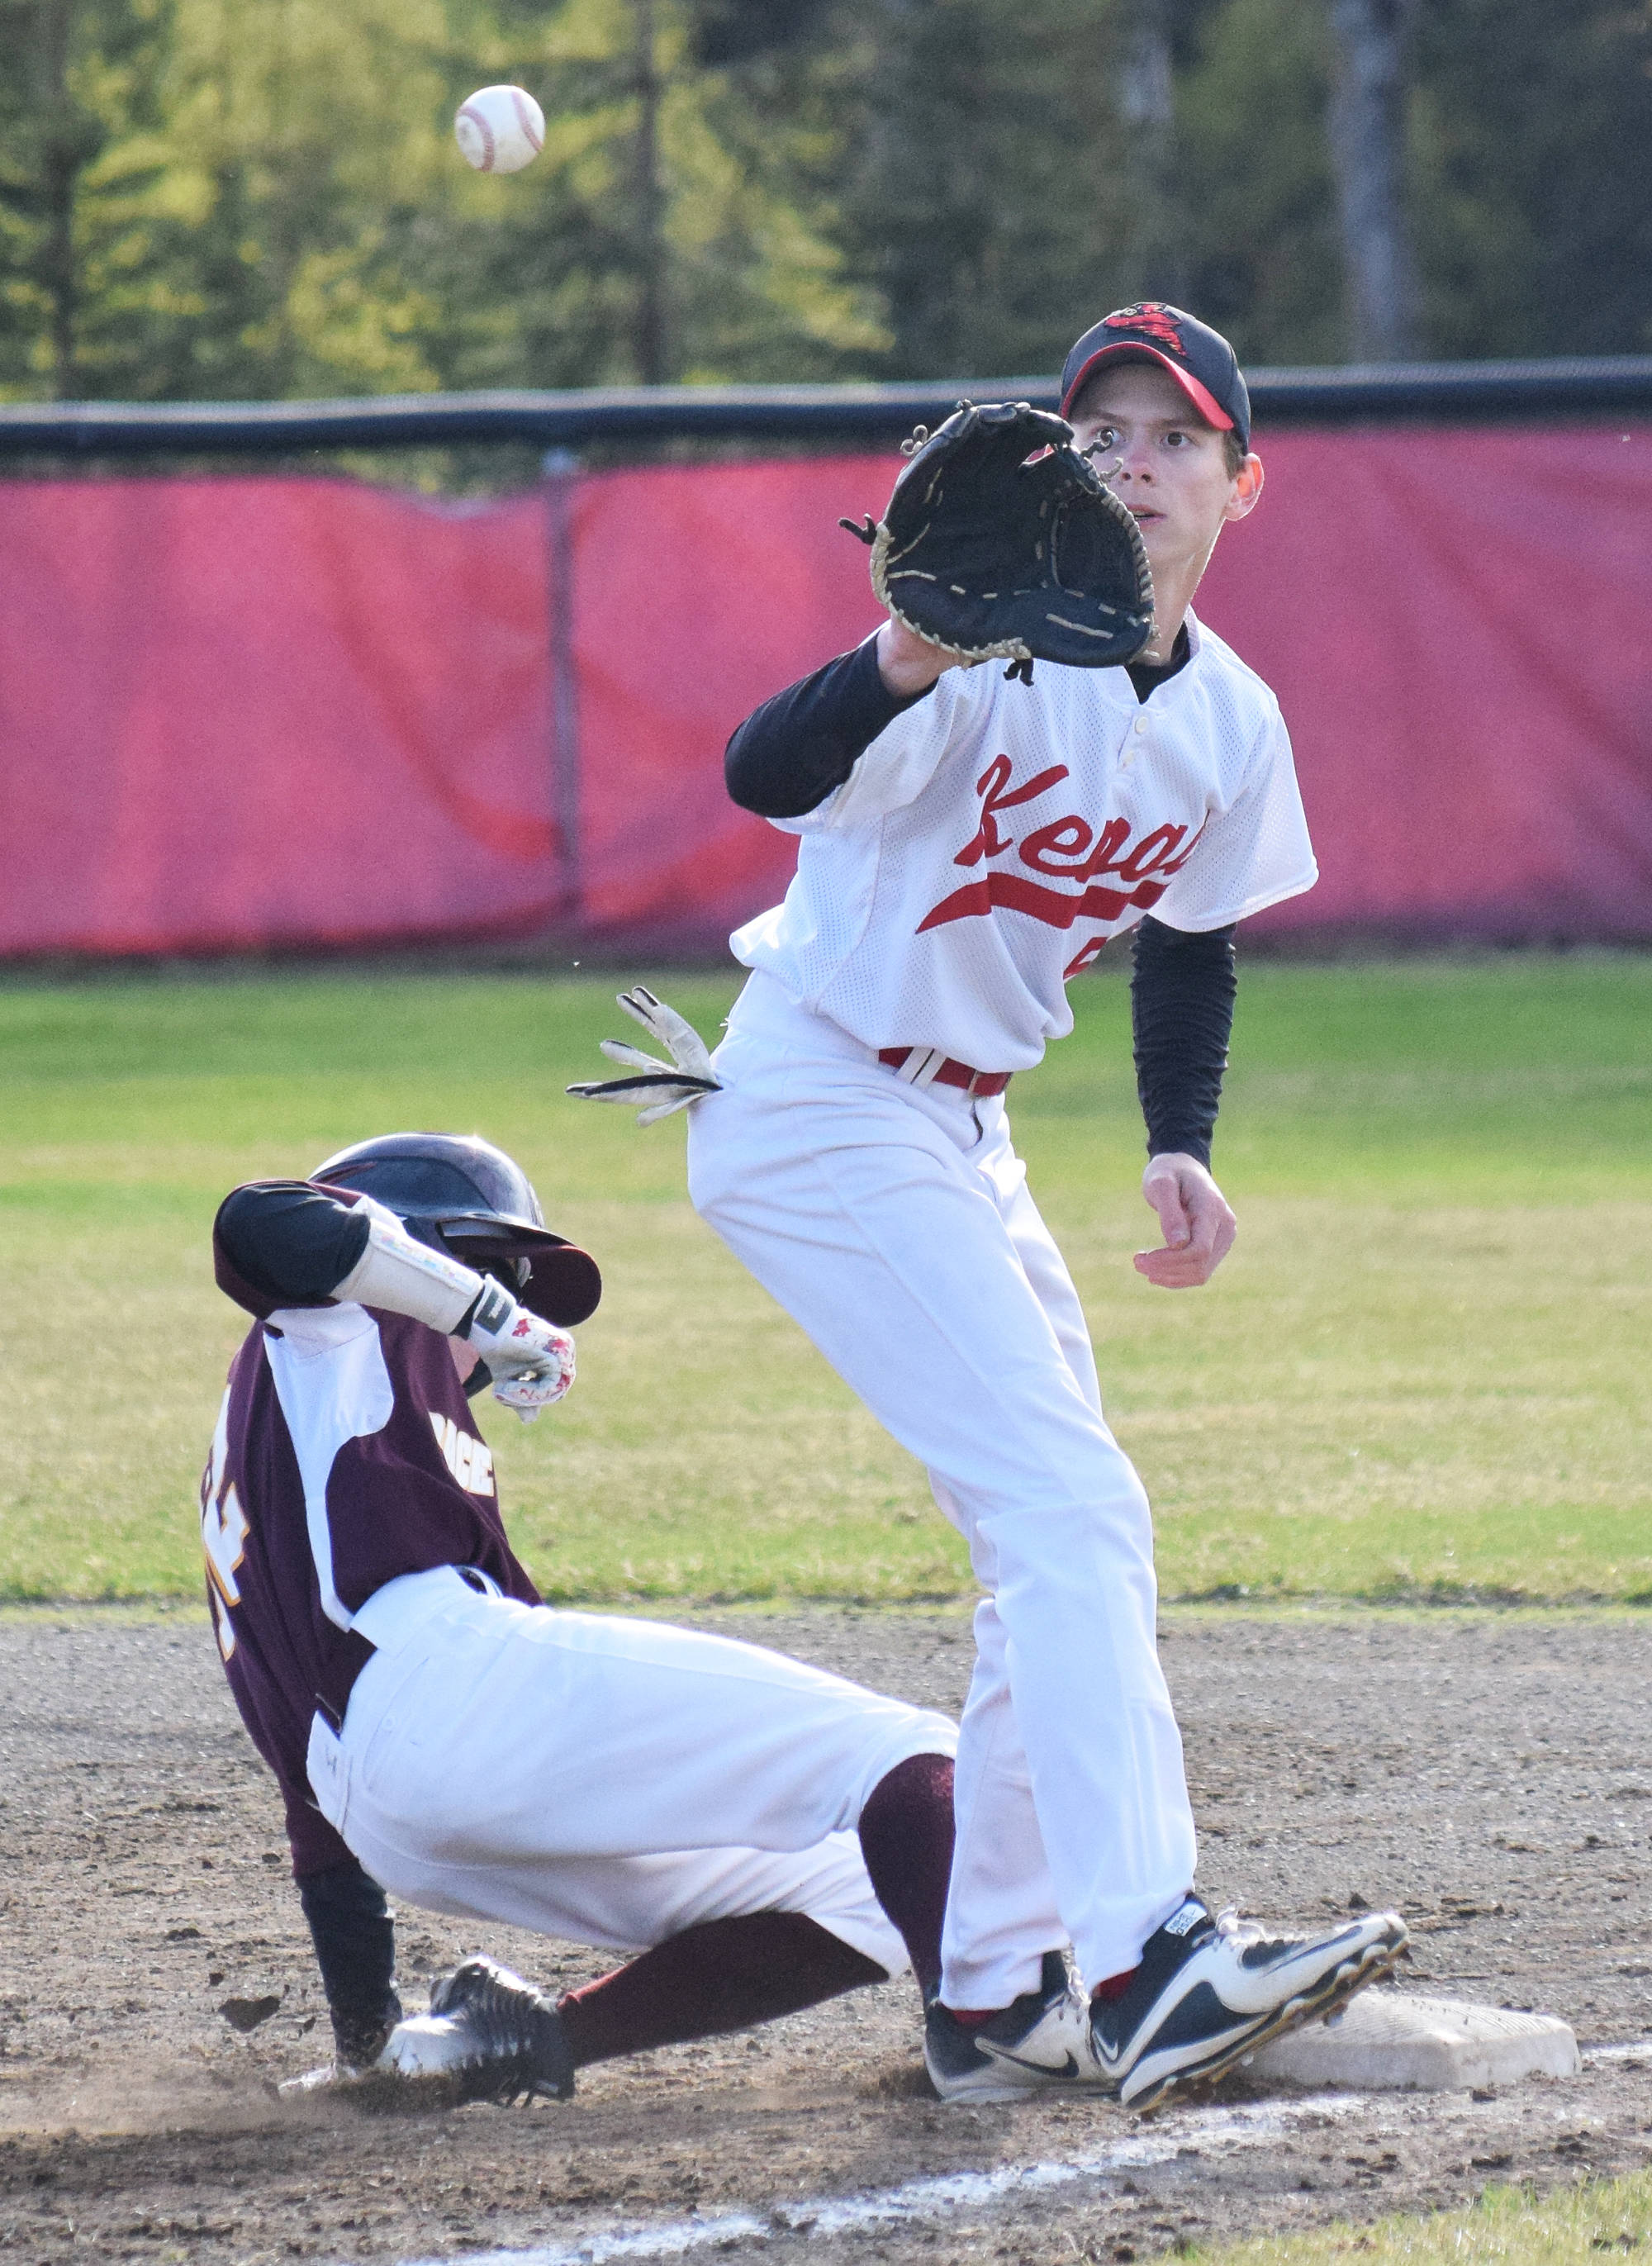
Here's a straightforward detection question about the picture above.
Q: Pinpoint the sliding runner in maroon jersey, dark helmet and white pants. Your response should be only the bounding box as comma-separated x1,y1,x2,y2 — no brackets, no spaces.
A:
202,1133,965,2098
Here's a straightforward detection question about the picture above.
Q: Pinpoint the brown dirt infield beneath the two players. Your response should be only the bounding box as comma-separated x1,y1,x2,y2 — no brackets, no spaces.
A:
0,1611,1652,2262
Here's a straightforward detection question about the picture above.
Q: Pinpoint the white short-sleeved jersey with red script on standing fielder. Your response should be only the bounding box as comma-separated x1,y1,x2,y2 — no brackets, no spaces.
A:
729,614,1317,1070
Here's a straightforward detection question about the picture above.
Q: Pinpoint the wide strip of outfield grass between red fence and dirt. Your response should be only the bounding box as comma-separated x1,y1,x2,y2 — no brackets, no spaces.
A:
0,957,1652,1600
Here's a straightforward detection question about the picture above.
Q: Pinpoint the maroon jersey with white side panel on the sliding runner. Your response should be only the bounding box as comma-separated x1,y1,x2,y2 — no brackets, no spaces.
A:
202,1303,539,1876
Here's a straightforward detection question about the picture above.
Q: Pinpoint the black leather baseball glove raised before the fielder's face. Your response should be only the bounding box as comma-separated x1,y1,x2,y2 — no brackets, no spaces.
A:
838,401,1153,684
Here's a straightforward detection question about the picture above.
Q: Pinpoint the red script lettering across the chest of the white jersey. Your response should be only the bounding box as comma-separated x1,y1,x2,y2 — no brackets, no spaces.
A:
918,754,1203,936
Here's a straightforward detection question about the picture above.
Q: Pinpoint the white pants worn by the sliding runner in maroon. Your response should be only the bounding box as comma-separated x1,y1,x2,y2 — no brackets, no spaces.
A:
308,1565,957,1974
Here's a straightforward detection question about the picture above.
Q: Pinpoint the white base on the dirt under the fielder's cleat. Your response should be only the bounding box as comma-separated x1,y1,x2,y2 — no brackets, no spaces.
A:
1244,1989,1582,2094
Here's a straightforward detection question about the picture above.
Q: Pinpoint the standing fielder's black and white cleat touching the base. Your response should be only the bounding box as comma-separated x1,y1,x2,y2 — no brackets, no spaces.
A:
1090,1897,1409,2110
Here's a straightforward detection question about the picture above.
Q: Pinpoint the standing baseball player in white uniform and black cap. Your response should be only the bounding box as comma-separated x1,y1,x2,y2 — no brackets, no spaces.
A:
671,304,1405,2107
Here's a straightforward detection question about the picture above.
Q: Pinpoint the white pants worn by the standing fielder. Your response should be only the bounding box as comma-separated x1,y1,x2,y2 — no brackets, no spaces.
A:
689,974,1197,2007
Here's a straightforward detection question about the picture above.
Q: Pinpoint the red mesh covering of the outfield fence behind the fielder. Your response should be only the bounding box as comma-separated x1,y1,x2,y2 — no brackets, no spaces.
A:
0,412,1652,957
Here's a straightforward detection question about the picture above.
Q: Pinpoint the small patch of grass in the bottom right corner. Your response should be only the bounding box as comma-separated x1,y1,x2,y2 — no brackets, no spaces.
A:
1194,2171,1652,2266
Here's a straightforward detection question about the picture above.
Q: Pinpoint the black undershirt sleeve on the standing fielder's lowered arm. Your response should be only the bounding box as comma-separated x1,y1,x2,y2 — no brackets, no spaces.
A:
1131,913,1237,1165
